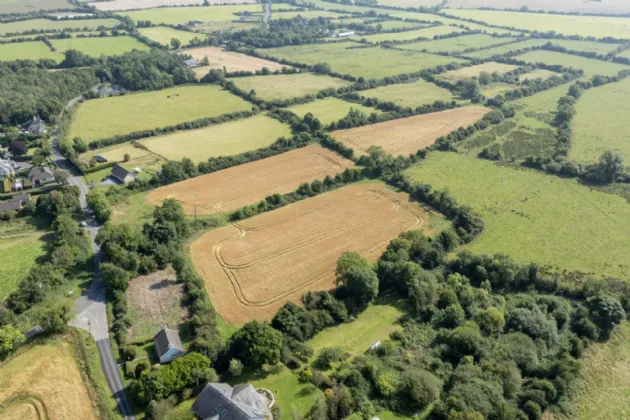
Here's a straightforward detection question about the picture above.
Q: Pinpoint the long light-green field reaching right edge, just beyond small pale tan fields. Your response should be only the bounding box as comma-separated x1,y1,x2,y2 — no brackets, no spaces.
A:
514,50,630,78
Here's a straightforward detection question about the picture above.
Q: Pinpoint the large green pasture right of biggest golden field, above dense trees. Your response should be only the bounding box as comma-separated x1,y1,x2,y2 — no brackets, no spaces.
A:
407,152,630,279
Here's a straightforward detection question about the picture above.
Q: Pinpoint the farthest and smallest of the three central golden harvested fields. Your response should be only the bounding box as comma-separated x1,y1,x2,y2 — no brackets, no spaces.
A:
332,107,490,155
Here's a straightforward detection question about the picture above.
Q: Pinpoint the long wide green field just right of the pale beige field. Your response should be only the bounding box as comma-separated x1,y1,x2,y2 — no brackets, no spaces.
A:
258,42,464,79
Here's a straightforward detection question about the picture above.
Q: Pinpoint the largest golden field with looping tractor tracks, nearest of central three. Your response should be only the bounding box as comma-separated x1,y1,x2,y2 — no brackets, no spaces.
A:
190,183,440,325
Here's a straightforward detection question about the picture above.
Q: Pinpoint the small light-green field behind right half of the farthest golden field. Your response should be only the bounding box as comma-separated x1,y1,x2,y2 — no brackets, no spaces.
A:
358,79,453,108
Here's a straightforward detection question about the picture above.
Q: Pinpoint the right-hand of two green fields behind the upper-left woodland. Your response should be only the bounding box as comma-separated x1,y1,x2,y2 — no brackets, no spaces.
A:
50,36,149,58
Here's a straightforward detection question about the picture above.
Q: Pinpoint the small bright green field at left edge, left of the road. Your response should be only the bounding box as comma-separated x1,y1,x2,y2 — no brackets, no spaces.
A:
0,233,48,298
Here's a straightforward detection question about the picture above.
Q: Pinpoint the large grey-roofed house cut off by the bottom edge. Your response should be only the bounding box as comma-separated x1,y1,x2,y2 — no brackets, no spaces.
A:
192,383,269,420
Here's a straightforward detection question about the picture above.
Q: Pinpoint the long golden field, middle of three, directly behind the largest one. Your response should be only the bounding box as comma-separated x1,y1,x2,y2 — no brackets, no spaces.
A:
147,145,354,214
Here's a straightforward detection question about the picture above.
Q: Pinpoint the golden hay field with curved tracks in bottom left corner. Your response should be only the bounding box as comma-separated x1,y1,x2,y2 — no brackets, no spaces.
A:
0,338,99,420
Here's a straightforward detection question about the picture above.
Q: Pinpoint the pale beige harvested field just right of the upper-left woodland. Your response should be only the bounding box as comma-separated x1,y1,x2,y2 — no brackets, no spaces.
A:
182,47,291,75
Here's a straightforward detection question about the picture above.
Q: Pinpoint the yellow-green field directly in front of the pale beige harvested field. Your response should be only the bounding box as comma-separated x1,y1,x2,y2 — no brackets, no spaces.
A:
230,73,351,100
